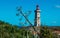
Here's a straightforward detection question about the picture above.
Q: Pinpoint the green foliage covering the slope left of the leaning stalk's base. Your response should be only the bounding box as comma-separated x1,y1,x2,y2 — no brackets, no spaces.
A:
0,21,32,38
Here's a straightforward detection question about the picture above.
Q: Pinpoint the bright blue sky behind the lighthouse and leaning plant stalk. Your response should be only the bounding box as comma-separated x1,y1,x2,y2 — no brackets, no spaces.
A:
0,0,60,26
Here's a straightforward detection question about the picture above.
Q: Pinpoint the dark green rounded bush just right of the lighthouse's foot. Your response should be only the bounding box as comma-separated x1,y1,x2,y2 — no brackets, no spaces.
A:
40,26,53,38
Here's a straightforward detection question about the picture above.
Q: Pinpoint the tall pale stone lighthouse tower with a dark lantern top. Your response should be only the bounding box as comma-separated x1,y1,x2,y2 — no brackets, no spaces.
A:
34,5,41,26
